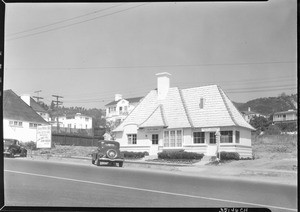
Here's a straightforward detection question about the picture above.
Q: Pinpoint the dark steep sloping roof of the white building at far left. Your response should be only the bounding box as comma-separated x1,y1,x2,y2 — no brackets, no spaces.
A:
3,90,49,124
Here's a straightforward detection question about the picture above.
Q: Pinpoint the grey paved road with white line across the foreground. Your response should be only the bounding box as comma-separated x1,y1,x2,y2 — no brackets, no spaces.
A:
4,158,297,211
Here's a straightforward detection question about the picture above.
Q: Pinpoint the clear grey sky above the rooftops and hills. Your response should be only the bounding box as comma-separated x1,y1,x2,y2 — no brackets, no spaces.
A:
3,0,297,109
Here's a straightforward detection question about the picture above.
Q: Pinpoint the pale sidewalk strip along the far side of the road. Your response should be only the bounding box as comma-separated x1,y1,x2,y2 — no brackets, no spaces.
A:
28,155,298,186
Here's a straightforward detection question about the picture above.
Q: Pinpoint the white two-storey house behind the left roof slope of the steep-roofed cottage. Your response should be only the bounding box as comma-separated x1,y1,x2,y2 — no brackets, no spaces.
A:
105,94,143,123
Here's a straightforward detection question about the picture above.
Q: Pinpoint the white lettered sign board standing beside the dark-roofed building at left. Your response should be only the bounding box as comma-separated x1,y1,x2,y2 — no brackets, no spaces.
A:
36,125,51,148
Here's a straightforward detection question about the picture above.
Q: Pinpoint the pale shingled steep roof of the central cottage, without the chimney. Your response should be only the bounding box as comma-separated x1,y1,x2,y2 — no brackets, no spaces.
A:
114,85,255,131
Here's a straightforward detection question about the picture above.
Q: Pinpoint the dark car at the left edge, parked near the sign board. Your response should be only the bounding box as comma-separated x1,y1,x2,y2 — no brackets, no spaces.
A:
3,139,27,158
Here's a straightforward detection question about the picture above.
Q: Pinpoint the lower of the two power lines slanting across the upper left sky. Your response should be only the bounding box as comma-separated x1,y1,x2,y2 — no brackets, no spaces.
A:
6,3,149,41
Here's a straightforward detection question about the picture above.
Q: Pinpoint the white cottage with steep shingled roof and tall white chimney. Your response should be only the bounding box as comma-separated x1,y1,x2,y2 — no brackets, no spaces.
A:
113,72,255,158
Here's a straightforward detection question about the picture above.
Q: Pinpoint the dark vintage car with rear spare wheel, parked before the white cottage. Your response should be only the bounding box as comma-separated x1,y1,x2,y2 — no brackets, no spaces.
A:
92,141,124,167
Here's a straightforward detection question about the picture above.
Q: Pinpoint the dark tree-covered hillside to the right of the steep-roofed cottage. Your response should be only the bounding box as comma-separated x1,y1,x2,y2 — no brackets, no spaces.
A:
234,94,297,115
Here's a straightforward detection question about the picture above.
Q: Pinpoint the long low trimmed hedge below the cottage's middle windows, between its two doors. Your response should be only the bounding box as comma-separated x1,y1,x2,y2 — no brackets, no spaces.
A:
157,150,204,160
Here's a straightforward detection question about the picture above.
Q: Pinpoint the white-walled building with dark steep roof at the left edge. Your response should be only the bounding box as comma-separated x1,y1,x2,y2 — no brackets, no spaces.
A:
3,90,49,142
